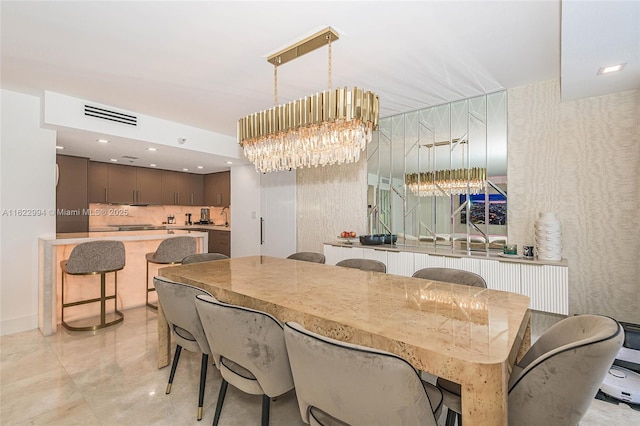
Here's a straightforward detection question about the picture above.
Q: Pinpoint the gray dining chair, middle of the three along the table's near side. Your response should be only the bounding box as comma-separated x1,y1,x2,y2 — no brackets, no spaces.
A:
196,296,293,426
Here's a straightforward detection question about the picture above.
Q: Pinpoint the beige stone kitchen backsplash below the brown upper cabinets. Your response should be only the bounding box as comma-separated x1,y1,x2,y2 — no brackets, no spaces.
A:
89,203,231,229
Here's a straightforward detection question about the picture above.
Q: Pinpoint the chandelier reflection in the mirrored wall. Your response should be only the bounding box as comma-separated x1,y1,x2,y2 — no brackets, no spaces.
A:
404,167,487,197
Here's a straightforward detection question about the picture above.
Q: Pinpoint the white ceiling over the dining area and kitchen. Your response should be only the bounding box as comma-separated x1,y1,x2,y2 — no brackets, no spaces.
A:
0,0,640,173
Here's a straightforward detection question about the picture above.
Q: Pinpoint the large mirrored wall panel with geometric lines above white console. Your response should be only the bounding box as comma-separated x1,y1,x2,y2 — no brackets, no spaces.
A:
367,91,507,251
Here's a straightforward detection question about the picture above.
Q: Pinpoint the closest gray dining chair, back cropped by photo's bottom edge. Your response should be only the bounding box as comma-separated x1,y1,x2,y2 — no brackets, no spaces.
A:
284,322,442,426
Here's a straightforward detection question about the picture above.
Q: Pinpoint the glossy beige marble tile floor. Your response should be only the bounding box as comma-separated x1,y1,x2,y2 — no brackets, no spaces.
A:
0,308,640,426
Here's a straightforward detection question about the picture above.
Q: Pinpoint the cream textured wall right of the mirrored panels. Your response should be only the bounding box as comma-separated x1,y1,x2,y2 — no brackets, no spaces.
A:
508,80,640,323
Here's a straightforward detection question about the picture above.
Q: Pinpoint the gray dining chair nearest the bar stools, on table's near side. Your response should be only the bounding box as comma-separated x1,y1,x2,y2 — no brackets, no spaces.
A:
153,277,217,420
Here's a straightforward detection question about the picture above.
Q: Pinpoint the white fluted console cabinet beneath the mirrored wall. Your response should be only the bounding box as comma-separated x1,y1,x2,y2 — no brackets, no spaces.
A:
324,243,569,315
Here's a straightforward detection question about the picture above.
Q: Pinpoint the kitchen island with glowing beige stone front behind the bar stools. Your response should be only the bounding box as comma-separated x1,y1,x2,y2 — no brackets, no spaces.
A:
38,229,209,336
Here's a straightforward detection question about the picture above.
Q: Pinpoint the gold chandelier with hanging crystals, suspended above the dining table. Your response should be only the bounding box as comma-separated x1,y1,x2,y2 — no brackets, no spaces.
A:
238,27,379,173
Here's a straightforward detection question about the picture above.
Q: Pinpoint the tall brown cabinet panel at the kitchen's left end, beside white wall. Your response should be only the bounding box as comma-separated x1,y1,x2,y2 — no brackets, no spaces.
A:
56,155,89,233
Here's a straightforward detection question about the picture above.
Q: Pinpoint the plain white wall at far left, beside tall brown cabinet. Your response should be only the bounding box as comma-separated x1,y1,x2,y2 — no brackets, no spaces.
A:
0,90,56,335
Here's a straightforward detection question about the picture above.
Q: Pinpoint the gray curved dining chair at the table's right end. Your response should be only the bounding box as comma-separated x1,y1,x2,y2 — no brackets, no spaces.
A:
440,315,624,426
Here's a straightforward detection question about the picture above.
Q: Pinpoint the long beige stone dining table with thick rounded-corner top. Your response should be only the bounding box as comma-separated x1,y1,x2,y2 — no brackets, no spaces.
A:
158,256,531,425
